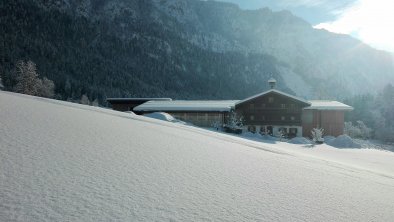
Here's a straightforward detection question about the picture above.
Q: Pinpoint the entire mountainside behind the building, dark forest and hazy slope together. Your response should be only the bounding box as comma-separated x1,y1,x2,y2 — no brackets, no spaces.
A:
0,0,394,103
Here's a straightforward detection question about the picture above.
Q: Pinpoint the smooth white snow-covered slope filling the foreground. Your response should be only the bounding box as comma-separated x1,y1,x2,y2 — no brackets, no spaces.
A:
0,92,394,221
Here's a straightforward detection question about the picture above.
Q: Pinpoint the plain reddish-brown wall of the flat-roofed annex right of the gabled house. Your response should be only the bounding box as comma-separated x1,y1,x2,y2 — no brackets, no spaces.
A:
302,109,345,137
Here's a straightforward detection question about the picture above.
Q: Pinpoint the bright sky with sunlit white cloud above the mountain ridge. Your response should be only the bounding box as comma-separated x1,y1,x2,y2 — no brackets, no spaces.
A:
220,0,394,52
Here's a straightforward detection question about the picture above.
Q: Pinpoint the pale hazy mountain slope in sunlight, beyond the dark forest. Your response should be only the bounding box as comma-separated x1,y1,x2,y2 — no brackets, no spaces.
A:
154,0,394,98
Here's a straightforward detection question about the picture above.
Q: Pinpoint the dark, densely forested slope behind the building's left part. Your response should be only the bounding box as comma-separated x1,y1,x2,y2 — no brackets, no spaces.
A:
0,0,289,102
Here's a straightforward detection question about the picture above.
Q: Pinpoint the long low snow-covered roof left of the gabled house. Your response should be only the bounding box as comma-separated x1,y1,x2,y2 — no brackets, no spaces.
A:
134,100,239,112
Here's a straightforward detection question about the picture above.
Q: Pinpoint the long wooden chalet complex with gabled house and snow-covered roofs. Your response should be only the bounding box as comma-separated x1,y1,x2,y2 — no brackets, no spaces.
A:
108,79,353,137
